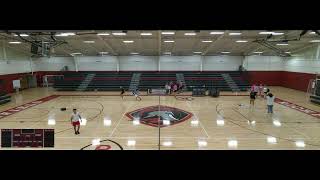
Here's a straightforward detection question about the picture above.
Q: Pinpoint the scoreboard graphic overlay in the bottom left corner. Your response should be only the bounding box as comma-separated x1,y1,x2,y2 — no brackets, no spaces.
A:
1,129,54,148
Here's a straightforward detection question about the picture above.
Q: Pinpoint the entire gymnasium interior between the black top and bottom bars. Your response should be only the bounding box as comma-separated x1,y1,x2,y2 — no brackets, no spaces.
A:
0,30,320,150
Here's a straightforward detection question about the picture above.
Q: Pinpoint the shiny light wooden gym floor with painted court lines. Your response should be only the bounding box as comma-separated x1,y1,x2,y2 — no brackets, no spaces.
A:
0,87,320,150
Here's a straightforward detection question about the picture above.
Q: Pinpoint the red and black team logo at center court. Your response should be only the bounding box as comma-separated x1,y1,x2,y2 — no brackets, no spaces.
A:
126,105,193,127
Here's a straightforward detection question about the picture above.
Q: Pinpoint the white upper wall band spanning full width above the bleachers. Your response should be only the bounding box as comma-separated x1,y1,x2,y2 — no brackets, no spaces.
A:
0,46,320,74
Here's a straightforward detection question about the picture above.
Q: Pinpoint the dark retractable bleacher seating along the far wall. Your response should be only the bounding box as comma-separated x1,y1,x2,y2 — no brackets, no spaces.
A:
54,71,249,91
